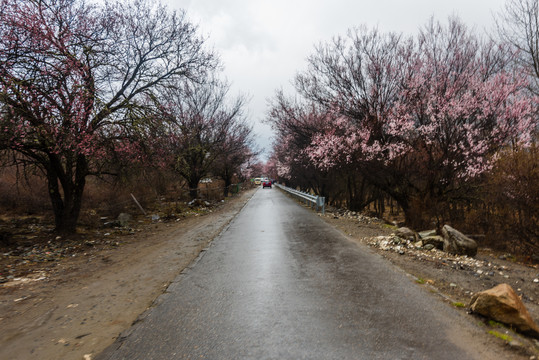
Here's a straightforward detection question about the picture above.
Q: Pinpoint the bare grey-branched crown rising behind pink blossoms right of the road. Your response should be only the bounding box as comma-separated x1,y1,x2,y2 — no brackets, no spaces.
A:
295,26,413,124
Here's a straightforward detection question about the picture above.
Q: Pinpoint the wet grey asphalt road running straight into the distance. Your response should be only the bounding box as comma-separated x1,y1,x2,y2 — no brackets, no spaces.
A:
97,189,484,360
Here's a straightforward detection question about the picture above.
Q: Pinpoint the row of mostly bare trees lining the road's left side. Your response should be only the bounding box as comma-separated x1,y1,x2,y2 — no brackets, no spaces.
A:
0,0,254,233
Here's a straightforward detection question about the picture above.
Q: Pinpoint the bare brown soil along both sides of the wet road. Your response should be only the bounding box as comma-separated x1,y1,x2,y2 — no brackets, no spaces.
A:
0,190,539,360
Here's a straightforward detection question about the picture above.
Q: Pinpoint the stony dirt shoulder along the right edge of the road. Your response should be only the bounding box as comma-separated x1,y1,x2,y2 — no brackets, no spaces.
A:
322,211,539,359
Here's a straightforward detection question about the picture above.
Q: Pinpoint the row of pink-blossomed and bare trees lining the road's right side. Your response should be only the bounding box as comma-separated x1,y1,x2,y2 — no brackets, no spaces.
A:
268,4,539,255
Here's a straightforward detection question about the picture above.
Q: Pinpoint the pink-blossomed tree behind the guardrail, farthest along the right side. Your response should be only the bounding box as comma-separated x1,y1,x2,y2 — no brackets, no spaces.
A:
270,93,378,210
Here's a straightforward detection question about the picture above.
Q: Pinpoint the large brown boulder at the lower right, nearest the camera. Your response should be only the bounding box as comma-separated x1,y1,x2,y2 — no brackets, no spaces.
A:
470,284,539,339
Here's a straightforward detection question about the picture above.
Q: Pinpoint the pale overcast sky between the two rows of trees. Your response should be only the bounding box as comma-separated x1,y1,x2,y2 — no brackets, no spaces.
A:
163,0,505,160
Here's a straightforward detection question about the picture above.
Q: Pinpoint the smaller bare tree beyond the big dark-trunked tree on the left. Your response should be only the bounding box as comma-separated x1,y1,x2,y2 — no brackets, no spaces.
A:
161,78,250,199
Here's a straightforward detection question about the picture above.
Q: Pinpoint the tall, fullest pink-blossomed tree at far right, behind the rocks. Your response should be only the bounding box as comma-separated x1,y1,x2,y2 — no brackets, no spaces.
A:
386,19,537,226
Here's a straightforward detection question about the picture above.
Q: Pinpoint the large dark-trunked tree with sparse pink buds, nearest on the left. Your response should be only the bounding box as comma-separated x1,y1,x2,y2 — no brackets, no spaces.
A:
0,0,215,232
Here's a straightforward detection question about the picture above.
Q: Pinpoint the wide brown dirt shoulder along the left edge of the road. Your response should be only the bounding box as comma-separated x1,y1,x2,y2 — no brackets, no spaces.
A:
0,189,256,360
